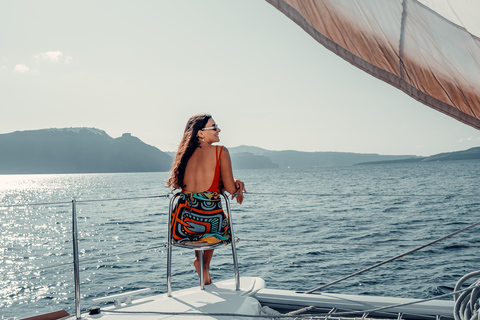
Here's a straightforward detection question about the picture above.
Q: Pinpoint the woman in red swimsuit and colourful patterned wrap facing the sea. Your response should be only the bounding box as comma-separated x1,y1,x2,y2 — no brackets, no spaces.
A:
168,114,246,284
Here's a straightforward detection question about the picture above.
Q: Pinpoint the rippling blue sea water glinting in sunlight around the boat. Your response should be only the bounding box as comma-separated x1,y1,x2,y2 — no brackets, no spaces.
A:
0,160,480,319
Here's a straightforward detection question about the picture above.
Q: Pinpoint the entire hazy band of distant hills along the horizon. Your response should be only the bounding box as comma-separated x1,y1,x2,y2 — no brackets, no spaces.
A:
0,128,480,174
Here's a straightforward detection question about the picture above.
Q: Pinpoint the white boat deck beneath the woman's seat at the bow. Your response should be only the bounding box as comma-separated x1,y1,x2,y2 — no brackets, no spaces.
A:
50,277,454,320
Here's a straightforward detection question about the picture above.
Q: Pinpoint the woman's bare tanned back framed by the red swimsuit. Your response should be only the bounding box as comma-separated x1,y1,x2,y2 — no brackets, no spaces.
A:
183,145,217,192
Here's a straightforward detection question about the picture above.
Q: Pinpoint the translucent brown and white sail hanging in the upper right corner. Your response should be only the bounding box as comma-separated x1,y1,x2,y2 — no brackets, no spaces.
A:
267,0,480,129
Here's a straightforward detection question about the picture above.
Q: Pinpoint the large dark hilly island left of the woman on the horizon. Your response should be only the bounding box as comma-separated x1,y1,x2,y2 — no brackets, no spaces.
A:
0,128,172,174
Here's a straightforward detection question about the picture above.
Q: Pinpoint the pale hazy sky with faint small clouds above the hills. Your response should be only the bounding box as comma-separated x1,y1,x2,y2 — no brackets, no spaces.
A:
0,0,480,156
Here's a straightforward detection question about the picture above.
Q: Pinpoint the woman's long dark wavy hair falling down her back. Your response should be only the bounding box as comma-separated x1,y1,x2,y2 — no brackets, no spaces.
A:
167,114,212,189
